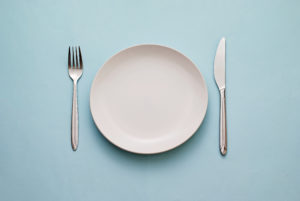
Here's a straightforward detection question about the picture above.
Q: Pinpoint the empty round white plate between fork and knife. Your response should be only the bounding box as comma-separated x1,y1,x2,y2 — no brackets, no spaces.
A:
90,45,208,154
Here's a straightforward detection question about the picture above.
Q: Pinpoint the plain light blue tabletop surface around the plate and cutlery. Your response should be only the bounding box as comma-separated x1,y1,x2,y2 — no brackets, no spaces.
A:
0,0,300,201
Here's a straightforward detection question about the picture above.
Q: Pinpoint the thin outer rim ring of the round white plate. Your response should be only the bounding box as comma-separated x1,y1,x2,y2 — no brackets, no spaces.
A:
89,43,208,155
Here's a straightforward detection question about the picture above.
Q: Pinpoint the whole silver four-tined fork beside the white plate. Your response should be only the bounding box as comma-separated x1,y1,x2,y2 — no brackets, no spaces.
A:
68,47,83,151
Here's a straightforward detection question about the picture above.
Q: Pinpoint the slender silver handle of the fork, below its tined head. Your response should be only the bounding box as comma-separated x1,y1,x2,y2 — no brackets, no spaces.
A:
71,81,78,151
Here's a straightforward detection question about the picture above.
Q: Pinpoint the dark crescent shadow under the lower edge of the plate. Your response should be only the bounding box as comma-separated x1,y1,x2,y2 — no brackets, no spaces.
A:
90,104,210,166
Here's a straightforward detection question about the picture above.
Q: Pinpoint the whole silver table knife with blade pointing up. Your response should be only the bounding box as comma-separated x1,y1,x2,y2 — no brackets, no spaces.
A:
214,38,227,156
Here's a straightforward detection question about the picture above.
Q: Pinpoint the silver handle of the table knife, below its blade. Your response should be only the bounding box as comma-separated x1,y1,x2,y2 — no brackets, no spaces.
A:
220,88,227,156
